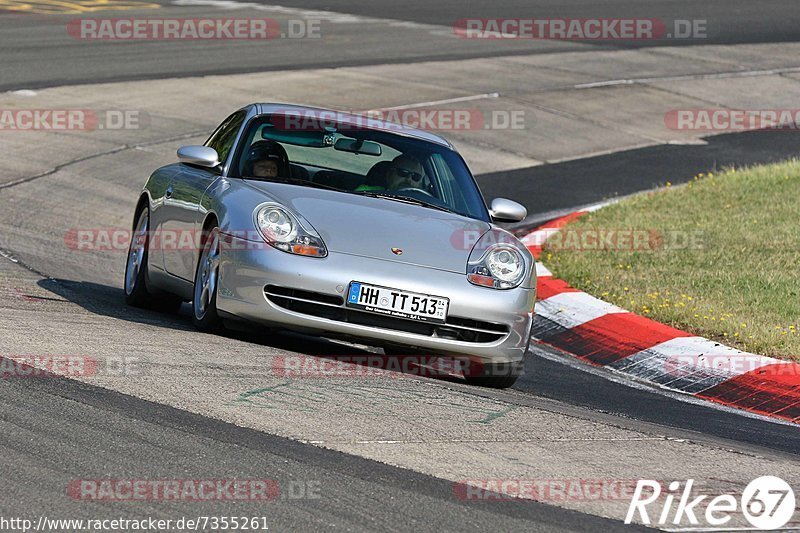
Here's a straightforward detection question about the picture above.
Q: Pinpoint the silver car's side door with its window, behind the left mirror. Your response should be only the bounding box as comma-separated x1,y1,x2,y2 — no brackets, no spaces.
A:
161,111,246,281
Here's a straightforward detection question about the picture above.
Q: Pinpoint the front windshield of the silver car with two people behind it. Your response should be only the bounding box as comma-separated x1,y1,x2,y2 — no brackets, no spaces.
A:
231,114,489,221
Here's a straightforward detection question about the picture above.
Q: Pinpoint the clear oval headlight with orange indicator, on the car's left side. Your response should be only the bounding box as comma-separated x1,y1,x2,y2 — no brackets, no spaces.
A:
255,204,328,257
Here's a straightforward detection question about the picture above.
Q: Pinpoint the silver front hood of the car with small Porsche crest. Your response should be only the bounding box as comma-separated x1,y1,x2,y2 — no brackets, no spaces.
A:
247,181,491,273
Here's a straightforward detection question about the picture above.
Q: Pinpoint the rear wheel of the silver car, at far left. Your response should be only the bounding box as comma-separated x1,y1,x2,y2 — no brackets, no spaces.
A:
123,206,183,313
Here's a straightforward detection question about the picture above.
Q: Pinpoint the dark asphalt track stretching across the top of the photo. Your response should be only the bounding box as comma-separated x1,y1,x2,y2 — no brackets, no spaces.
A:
0,0,800,90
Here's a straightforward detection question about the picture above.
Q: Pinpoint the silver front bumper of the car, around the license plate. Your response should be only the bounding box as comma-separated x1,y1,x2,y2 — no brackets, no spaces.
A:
217,236,536,363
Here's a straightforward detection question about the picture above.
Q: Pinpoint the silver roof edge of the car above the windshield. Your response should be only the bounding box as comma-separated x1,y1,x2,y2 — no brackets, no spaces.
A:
253,103,456,151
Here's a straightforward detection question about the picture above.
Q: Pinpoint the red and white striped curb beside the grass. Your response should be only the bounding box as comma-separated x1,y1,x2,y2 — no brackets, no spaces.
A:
522,206,800,423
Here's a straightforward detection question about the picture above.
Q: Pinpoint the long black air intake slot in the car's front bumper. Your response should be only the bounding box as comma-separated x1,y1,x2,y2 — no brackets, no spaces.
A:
264,285,509,344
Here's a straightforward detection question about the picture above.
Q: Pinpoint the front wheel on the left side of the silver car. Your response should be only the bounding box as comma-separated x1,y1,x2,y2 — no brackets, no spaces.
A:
192,225,225,333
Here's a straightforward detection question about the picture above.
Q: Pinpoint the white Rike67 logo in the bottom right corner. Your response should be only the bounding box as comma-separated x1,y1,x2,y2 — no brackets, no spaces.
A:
625,476,795,530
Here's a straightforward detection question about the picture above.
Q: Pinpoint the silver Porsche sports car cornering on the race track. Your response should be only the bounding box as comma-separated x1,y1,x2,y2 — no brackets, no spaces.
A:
125,104,536,387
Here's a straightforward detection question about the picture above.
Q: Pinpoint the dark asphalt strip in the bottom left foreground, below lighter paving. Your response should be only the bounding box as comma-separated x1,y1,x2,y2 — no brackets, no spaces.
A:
0,358,643,532
